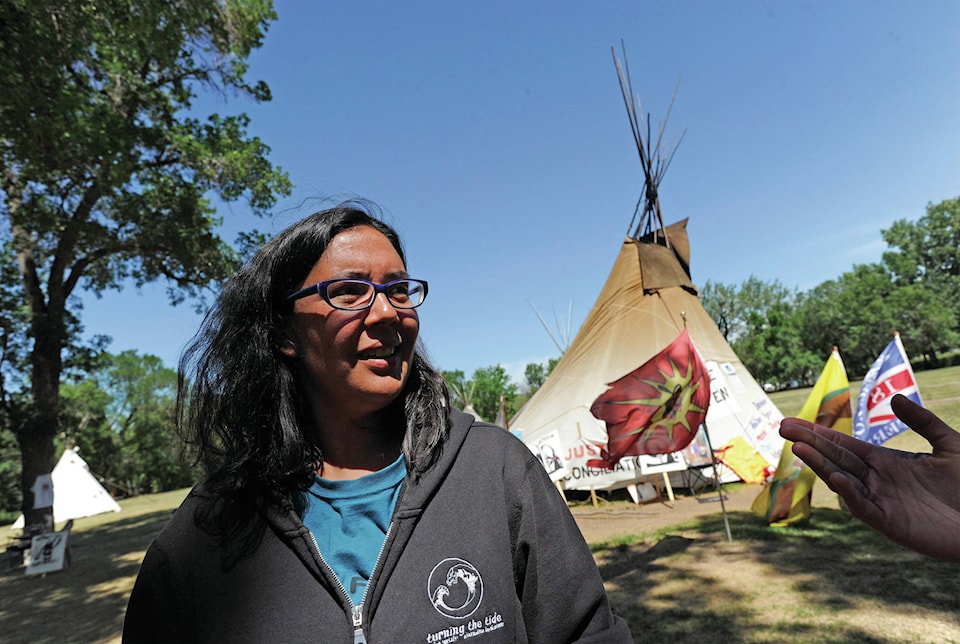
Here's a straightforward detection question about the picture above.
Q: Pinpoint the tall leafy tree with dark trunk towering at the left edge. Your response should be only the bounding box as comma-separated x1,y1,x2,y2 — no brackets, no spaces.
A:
0,0,290,523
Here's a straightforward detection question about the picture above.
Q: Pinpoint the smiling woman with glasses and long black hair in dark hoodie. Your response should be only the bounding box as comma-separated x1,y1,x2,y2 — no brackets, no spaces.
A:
124,204,631,644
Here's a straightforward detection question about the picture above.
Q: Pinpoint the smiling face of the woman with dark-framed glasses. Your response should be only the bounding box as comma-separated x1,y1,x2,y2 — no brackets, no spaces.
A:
281,226,420,419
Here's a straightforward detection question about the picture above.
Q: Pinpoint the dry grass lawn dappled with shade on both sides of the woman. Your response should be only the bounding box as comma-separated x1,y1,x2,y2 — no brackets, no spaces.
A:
0,367,960,643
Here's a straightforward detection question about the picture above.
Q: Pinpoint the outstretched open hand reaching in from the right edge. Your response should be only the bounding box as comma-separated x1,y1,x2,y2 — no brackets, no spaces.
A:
780,394,960,561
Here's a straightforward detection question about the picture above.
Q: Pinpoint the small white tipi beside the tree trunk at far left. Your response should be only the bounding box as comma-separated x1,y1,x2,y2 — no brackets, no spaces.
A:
13,448,120,528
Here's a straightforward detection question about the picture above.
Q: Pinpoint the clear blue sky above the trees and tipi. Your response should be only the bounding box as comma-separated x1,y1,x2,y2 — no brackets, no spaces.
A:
83,0,960,378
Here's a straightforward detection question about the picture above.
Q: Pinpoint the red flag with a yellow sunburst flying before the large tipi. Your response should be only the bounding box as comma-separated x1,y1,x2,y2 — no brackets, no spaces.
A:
587,329,710,469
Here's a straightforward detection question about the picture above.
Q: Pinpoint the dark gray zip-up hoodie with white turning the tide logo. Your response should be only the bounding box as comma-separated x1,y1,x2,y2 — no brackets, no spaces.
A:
123,411,632,644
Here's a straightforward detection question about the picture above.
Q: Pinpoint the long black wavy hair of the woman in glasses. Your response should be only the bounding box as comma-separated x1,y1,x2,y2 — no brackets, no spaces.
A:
177,202,450,504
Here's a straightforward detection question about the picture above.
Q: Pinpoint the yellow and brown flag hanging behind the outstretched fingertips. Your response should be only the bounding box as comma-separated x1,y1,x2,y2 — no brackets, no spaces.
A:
751,347,853,526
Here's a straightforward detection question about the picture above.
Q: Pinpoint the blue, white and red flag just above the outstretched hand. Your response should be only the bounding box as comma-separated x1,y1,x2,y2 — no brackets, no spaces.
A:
853,332,923,445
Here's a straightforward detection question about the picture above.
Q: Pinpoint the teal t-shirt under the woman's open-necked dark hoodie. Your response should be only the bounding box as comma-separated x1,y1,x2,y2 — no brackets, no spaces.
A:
303,456,407,606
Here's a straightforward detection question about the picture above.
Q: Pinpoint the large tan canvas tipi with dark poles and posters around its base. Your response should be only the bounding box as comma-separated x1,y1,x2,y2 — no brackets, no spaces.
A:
511,47,783,489
